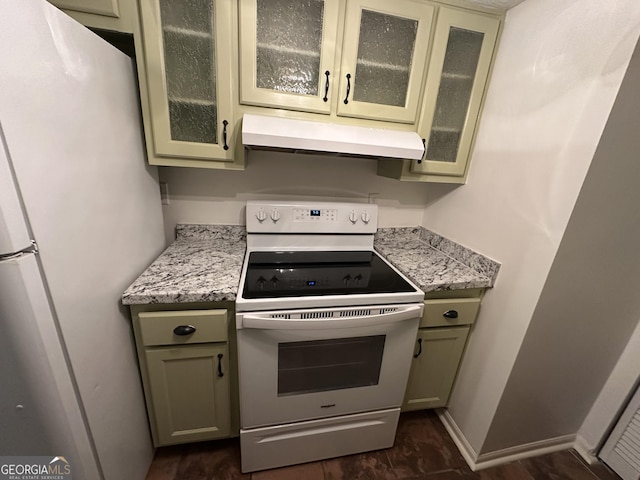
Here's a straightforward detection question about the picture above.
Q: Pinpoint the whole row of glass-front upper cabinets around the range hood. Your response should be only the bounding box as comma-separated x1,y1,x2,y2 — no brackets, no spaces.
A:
130,0,503,175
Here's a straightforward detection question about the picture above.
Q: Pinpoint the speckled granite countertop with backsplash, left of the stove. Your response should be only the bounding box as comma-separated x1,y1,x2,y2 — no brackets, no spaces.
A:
122,225,246,305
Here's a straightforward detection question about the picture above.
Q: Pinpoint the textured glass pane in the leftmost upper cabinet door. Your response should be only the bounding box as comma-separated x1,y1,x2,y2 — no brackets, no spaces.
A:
160,0,218,144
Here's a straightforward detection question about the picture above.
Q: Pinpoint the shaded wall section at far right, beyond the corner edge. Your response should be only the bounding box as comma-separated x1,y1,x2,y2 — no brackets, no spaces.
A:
482,34,640,451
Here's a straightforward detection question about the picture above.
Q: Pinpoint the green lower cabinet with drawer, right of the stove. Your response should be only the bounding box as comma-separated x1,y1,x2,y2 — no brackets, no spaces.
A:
402,298,480,411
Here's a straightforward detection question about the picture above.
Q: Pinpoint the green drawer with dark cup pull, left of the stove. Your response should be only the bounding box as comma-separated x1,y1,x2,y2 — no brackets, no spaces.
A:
139,309,227,346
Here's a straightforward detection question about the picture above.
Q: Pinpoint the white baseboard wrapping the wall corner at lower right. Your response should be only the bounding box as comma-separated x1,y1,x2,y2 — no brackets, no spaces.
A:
438,410,582,472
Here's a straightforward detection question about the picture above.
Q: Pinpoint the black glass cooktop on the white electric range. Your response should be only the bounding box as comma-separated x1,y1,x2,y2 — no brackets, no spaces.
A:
242,251,415,298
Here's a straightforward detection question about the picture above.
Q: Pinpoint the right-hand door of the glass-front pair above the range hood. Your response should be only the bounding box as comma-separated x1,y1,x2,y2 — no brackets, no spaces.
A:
338,0,434,123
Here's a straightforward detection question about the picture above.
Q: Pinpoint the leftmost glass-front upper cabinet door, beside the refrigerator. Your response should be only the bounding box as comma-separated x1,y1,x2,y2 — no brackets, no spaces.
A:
140,0,233,161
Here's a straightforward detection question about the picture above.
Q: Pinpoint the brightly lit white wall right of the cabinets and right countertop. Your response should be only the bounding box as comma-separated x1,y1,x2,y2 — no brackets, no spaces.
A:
423,0,640,453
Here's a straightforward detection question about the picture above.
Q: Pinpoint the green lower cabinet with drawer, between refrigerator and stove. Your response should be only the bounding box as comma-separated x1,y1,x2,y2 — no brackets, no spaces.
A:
132,307,237,447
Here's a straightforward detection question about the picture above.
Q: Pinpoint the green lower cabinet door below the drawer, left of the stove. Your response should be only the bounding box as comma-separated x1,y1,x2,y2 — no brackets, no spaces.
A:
145,343,231,446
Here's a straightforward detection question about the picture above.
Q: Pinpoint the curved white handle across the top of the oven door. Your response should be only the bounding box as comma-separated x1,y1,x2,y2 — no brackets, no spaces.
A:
241,303,424,330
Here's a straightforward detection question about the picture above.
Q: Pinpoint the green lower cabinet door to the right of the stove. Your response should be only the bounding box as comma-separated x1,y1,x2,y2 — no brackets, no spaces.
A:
402,327,469,411
